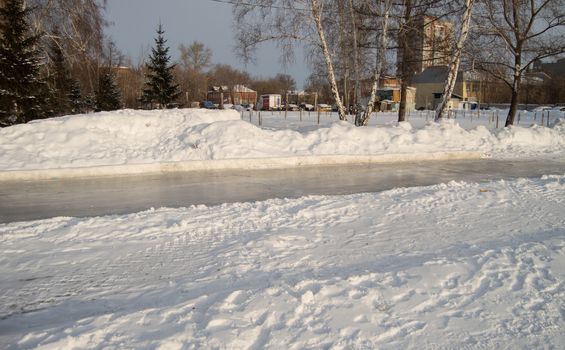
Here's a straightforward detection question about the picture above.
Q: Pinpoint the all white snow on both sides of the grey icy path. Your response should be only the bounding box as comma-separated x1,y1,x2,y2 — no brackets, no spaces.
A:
0,110,565,349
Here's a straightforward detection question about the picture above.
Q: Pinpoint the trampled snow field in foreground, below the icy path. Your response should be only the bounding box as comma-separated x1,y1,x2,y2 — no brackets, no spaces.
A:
0,176,565,349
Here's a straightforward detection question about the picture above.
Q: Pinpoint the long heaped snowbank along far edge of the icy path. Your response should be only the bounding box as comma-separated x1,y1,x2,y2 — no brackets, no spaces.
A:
0,109,565,171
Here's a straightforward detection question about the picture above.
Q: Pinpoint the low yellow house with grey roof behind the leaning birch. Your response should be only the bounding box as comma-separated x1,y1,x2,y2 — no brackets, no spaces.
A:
411,66,481,109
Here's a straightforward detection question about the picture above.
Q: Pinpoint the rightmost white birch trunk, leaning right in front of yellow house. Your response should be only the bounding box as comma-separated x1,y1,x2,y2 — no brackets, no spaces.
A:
435,0,474,121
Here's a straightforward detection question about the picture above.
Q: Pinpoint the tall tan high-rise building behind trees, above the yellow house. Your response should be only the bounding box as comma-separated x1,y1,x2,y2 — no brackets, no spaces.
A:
397,16,453,74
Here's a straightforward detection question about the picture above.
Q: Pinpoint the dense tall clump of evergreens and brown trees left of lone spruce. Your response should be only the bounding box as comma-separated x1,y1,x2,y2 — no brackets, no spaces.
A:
0,0,121,126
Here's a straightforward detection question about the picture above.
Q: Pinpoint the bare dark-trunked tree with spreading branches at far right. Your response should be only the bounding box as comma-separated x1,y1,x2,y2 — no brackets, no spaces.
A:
477,0,565,126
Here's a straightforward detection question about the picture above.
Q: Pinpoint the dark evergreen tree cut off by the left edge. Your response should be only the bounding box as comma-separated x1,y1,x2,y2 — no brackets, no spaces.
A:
0,0,48,126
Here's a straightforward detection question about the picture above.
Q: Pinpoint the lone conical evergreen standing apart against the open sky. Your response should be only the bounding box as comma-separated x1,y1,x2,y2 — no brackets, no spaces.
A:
142,24,180,108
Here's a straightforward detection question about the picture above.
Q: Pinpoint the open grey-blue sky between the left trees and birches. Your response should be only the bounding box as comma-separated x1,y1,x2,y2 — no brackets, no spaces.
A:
106,0,310,88
